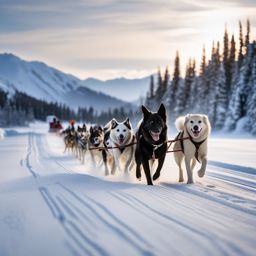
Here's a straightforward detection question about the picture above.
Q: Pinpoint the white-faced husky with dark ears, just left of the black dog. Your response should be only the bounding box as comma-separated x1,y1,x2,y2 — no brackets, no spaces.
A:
103,118,135,175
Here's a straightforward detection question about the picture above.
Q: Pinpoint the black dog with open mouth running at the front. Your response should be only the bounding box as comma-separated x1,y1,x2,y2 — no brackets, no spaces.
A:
135,104,167,185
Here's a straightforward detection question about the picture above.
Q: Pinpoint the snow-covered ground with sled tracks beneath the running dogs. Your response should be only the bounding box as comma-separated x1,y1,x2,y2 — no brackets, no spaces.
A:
0,123,256,256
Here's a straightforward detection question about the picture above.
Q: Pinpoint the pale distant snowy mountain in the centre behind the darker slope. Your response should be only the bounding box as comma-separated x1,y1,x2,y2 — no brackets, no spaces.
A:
83,76,150,102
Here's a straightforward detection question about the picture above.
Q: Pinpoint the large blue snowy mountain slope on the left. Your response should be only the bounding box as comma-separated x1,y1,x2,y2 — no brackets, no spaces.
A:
0,54,127,110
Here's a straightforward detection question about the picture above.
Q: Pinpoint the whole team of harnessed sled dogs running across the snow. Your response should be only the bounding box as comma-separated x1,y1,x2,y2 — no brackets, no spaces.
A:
63,104,211,185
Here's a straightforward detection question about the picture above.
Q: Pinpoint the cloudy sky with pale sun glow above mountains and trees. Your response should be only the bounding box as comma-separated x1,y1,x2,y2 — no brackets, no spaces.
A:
0,0,256,79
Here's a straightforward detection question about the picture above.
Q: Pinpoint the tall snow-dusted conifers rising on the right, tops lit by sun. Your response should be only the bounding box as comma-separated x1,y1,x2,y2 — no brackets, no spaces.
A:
145,20,256,135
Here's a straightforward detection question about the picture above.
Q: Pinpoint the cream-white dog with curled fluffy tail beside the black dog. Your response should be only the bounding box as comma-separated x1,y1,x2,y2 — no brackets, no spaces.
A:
174,114,211,183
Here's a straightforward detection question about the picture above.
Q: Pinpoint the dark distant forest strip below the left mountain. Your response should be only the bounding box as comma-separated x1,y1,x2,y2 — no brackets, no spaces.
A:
0,89,138,127
